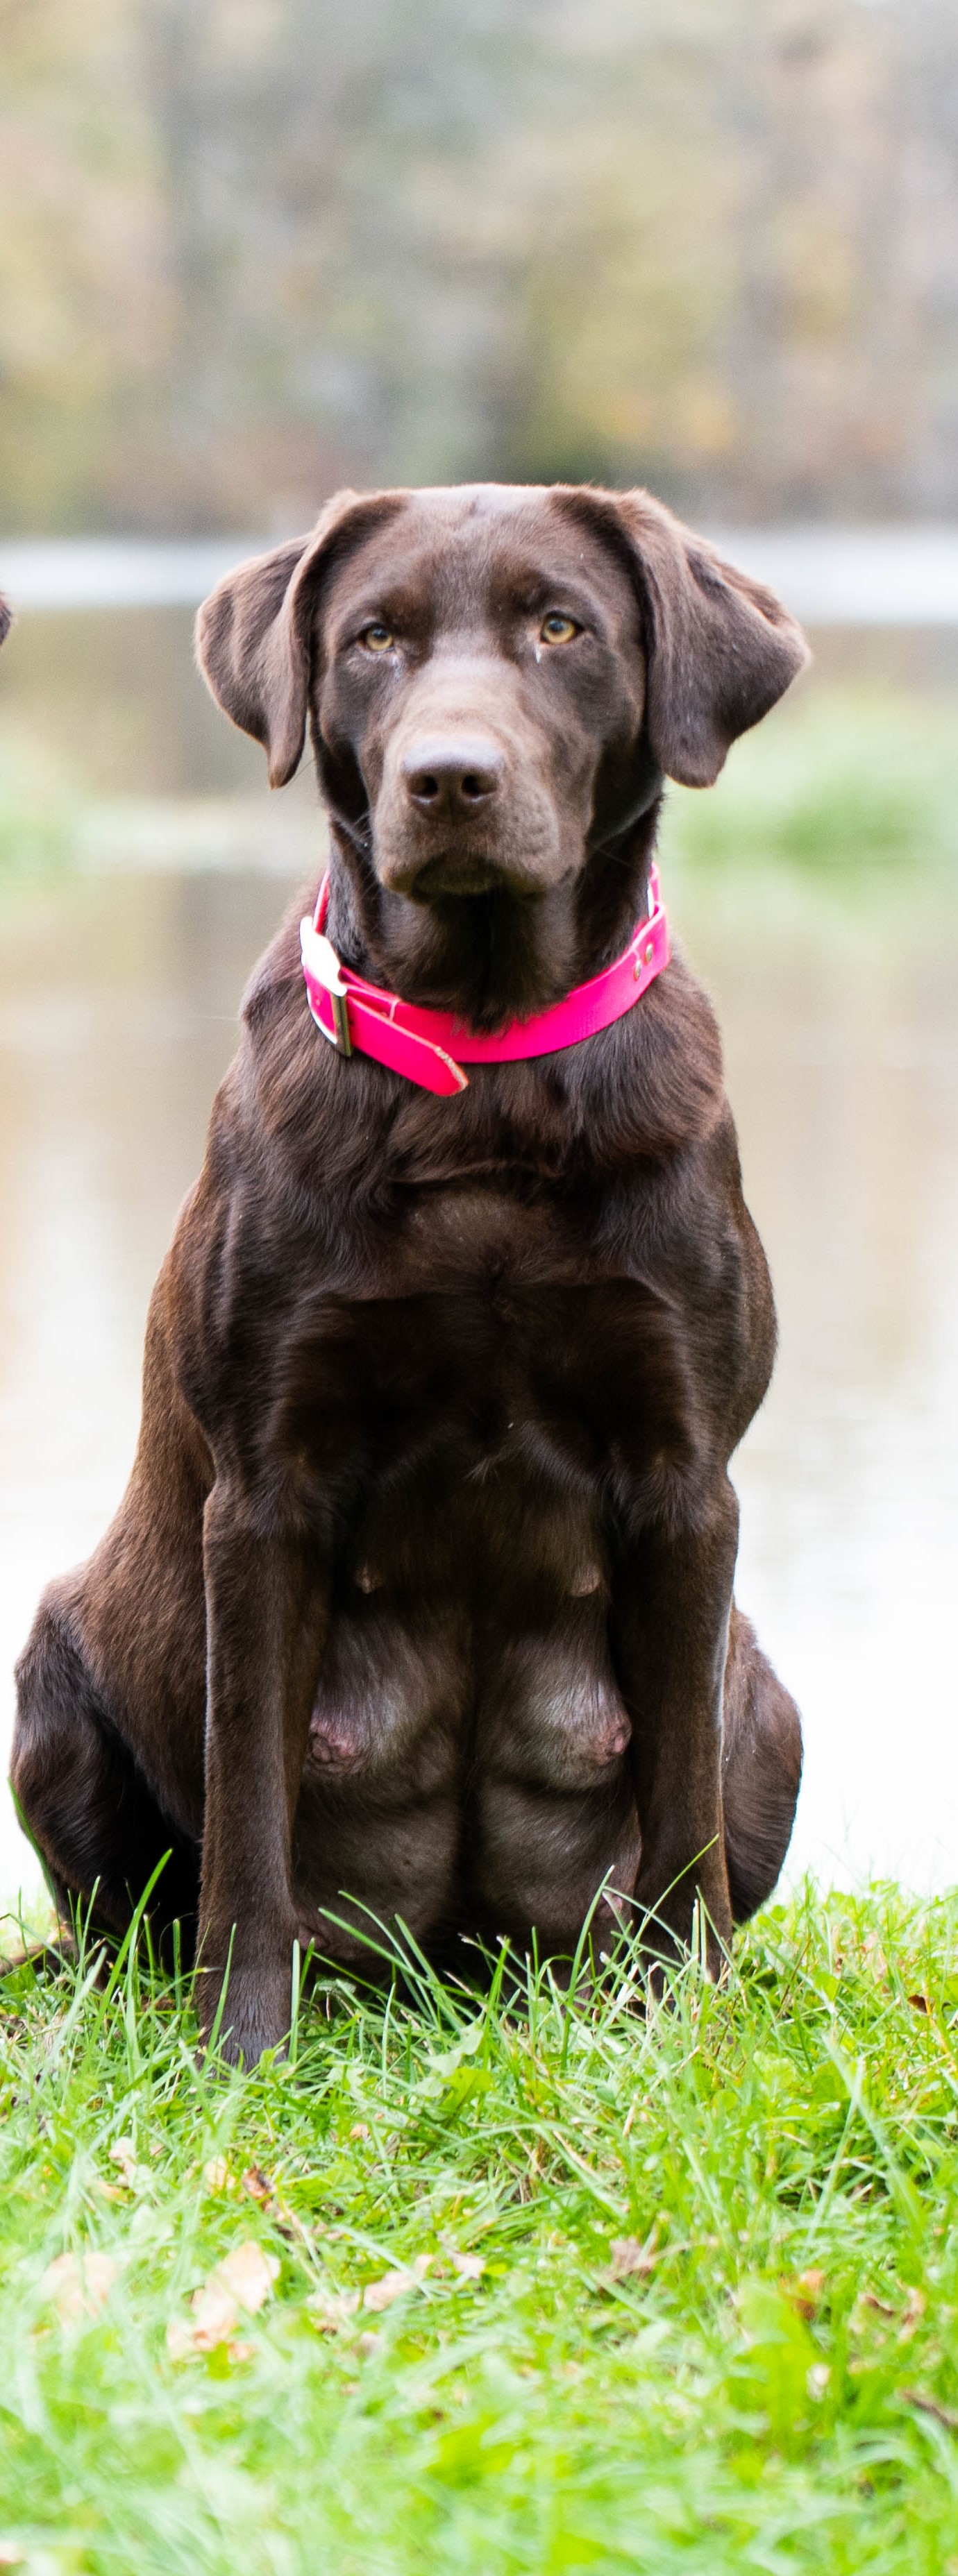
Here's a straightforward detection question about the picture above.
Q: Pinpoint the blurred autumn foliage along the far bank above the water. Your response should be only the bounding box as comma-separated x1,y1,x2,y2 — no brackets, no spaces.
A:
0,0,958,536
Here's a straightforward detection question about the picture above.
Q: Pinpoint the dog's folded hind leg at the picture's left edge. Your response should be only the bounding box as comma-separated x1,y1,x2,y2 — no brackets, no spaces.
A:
10,1595,199,1958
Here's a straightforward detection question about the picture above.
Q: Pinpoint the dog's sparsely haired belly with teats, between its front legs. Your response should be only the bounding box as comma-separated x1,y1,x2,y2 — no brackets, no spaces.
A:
296,1463,639,1960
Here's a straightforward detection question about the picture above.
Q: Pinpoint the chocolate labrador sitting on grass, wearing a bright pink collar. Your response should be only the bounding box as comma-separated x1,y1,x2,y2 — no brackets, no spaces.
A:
13,484,803,2063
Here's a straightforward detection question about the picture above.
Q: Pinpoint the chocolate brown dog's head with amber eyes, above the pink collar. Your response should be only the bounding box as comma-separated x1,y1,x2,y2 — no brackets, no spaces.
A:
199,484,806,1023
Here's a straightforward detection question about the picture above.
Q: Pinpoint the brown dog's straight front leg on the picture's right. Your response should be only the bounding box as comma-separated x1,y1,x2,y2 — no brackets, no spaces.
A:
613,1479,739,1976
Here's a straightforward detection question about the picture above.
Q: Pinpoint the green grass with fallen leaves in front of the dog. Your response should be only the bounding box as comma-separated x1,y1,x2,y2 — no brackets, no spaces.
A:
0,1888,958,2576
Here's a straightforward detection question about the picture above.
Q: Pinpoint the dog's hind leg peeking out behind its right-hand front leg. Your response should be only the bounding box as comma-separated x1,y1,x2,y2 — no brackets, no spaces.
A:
721,1610,801,1924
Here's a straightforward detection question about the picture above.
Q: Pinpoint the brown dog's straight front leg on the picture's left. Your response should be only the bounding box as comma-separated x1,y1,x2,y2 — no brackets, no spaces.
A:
199,1481,330,2066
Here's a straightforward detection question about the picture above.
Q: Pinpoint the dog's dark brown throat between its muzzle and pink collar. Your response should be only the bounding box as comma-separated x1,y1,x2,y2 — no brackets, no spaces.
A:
318,796,662,1031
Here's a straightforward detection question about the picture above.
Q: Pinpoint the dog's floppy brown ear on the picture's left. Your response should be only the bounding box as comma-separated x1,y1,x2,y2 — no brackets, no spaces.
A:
196,492,404,788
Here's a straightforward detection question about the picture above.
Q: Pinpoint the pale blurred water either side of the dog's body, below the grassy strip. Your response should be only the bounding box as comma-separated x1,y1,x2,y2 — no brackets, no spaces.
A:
0,845,958,1896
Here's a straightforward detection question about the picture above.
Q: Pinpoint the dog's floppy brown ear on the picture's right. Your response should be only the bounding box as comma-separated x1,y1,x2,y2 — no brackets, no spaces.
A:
564,492,809,788
